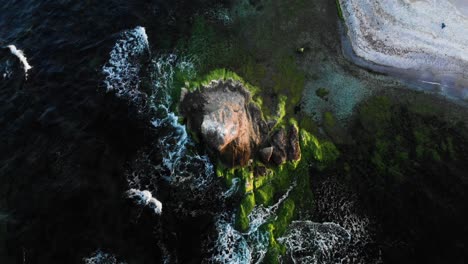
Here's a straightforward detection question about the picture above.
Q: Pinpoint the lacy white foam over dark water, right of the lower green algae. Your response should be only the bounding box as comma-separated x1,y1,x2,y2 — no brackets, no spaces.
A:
306,178,381,264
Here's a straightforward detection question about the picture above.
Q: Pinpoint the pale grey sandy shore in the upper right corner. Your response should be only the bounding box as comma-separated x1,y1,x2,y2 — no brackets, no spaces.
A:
340,0,468,99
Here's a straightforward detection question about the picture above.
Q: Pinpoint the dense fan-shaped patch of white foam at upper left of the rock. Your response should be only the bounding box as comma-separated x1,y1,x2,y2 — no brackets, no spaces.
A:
102,26,149,99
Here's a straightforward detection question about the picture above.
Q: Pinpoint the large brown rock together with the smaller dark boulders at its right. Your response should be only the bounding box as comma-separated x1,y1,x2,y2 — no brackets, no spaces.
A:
179,80,300,167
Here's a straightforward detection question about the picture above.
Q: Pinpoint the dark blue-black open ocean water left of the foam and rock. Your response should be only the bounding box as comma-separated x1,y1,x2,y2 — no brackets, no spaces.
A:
0,0,230,263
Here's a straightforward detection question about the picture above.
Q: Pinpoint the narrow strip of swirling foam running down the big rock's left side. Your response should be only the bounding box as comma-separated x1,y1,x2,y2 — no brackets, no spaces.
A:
146,54,214,189
